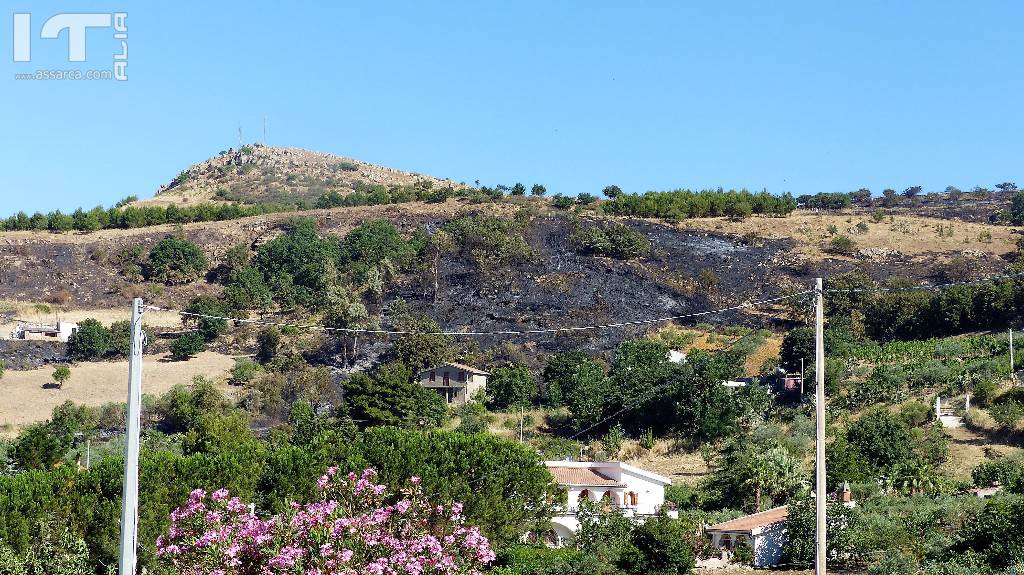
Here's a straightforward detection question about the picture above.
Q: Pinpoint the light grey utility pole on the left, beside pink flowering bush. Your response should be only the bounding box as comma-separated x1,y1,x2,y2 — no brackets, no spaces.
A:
118,298,143,575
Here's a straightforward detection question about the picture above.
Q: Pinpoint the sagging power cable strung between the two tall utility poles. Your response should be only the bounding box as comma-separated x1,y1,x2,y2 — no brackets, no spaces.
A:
147,290,813,337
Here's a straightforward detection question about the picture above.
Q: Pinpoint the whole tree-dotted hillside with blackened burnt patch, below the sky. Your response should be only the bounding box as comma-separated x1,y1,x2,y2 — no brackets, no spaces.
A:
0,153,1024,575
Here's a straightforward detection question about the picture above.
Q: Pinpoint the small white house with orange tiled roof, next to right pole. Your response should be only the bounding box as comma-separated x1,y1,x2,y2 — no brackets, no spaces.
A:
705,505,788,567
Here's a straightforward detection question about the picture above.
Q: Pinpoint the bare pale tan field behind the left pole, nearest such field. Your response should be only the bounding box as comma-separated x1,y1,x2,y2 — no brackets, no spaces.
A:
0,352,234,434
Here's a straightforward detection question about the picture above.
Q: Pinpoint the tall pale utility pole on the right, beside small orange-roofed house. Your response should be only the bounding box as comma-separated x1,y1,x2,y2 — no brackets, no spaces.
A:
814,277,828,575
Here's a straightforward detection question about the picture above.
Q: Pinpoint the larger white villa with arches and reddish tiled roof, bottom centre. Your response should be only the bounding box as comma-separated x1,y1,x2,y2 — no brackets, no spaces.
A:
544,461,678,545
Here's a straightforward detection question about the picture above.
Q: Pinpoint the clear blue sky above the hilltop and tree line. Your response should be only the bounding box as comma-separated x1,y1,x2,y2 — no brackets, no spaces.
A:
0,0,1024,214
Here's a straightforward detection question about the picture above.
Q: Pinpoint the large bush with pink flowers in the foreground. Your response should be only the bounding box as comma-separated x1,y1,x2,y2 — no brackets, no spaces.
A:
157,468,495,575
